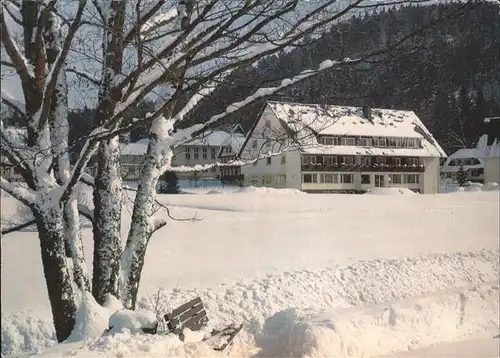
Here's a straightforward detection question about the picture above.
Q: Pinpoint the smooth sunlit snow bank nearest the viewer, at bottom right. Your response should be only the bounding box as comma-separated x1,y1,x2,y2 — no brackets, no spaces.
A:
260,281,499,357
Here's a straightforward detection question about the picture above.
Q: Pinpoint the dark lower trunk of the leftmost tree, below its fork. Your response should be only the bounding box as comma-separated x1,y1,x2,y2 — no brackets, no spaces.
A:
33,209,78,343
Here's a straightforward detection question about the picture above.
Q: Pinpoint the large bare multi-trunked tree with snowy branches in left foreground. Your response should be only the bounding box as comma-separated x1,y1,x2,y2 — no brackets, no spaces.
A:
0,0,472,342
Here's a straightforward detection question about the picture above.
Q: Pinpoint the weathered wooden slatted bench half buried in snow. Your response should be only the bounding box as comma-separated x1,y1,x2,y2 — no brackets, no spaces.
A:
165,297,243,352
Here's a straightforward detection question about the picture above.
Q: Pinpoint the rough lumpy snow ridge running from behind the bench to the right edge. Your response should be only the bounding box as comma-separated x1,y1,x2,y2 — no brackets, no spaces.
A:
138,250,499,356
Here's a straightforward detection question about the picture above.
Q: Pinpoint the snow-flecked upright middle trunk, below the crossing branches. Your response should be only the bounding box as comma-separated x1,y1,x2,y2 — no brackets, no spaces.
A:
92,137,122,305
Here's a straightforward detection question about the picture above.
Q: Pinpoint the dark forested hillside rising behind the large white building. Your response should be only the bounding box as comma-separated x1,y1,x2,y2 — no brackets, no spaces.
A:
188,1,500,153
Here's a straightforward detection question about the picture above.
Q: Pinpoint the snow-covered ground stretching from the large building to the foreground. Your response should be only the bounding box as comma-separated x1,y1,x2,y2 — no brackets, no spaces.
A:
1,188,500,357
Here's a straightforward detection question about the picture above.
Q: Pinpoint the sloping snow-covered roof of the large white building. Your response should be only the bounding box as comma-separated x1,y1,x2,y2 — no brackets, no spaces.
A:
268,101,446,157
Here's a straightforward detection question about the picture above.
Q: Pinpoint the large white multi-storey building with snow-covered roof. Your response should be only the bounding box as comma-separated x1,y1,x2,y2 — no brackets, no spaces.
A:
239,102,446,193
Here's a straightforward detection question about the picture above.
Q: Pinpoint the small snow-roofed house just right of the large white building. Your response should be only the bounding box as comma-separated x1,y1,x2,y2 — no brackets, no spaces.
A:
441,148,484,183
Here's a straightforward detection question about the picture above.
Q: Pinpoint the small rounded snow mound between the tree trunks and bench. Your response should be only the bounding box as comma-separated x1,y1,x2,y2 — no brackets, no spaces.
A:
108,309,158,334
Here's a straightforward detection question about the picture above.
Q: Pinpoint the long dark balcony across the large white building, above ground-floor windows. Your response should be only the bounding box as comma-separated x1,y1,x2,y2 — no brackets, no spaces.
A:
302,163,425,173
